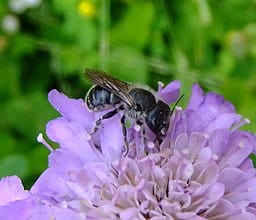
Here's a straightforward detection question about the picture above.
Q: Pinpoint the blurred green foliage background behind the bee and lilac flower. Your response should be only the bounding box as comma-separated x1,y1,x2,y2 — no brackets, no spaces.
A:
0,0,256,187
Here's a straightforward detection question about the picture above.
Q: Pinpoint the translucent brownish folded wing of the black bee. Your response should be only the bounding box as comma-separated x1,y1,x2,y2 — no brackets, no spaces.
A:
84,68,134,106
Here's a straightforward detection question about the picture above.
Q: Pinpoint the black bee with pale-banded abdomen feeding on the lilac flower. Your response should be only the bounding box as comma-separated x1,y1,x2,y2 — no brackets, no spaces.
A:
84,68,180,155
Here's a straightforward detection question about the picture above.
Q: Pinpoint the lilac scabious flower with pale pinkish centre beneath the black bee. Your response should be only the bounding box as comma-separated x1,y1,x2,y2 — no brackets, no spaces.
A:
0,81,256,220
